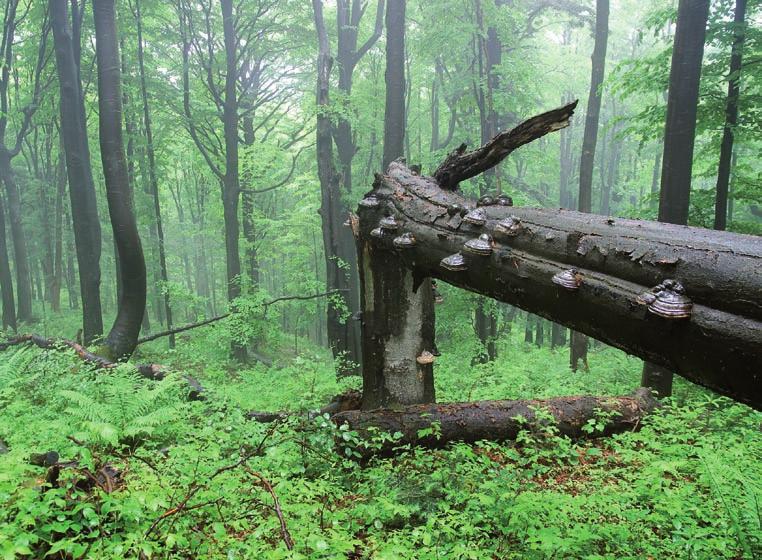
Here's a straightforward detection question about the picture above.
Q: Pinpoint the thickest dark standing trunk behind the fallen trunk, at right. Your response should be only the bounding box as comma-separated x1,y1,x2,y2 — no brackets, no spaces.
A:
641,0,709,397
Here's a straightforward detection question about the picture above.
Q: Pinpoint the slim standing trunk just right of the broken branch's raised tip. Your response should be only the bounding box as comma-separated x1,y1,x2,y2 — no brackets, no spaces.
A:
569,0,609,371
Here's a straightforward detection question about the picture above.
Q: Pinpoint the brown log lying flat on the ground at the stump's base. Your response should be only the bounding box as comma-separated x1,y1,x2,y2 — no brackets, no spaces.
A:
333,389,658,456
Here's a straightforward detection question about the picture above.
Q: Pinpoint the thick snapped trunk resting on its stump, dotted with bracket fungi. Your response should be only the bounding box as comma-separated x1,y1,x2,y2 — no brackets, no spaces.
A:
356,162,762,409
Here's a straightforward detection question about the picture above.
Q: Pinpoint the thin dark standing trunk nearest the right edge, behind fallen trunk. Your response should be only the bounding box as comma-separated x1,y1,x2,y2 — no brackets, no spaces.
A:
714,0,746,229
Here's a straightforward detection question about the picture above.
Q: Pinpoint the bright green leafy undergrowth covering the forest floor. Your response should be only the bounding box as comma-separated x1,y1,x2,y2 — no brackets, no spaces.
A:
0,312,762,559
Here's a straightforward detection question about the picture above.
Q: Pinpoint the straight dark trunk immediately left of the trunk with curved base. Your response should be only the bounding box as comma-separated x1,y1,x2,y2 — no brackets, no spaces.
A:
49,0,103,344
